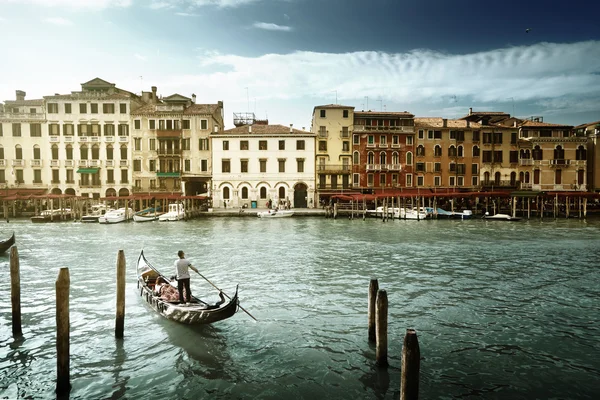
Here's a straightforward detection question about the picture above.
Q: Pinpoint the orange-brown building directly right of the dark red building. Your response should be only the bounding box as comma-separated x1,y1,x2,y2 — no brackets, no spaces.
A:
413,118,481,190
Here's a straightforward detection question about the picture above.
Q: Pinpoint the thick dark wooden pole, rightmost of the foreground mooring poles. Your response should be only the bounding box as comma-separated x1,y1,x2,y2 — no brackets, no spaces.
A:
400,329,421,400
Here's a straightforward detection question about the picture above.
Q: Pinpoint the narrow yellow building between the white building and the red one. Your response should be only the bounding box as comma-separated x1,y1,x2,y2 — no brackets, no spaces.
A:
311,104,354,202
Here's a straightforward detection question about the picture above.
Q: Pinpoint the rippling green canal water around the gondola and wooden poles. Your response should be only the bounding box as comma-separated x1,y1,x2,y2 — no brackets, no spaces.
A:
0,217,600,400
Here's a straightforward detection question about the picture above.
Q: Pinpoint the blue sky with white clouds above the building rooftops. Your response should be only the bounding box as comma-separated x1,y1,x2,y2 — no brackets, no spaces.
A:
0,0,600,130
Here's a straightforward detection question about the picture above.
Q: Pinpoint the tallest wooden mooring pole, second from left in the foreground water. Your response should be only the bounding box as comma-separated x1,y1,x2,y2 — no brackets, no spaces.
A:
56,268,71,394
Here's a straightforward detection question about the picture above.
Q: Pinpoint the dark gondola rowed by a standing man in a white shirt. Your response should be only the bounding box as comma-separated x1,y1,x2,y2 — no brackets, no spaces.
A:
137,250,238,325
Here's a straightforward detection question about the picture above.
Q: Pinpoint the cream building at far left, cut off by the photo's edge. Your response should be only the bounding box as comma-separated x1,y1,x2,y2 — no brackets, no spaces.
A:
0,90,45,191
